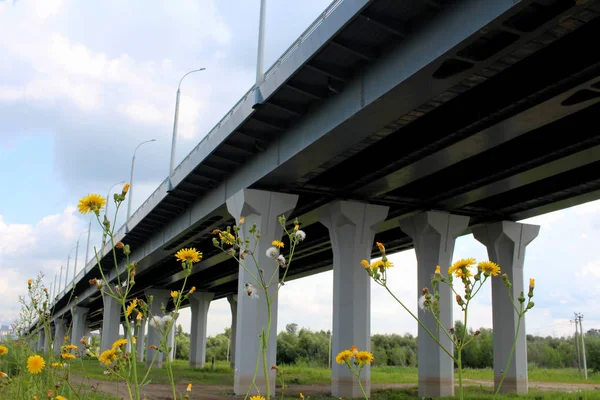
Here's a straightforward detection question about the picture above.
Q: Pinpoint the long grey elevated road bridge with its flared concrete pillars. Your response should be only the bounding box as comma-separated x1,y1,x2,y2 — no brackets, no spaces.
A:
30,0,600,397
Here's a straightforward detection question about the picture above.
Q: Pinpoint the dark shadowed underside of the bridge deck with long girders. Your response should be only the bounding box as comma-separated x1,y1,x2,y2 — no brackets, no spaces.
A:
50,0,600,327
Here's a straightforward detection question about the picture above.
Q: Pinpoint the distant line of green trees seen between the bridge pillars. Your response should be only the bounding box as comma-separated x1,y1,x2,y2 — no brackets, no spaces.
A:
171,321,600,371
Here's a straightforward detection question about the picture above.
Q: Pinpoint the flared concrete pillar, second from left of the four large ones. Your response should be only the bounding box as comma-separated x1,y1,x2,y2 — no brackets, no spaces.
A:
320,201,388,398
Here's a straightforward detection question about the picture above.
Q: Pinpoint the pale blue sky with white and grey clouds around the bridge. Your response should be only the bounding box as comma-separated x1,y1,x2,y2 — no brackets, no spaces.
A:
0,0,600,335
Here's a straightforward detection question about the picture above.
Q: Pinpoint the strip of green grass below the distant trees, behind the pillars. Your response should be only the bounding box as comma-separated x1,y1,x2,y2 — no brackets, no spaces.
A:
72,360,600,385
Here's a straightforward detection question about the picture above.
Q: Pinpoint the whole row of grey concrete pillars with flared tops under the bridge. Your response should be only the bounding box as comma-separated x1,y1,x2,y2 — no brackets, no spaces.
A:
85,189,539,397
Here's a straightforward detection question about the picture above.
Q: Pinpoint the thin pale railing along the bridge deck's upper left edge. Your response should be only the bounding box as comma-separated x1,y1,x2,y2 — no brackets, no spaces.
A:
49,0,344,312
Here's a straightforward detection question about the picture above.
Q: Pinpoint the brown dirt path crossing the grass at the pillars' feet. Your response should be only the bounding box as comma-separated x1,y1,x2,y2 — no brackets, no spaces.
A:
78,379,600,400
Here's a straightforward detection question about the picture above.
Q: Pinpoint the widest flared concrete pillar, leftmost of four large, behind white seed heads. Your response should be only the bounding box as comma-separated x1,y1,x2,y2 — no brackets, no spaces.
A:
227,189,298,395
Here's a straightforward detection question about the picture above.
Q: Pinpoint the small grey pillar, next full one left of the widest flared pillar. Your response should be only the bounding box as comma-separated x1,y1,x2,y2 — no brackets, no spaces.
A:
190,292,215,368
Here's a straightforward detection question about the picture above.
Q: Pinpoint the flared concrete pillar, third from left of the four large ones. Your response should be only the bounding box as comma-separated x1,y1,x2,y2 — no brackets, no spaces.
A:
400,211,469,397
